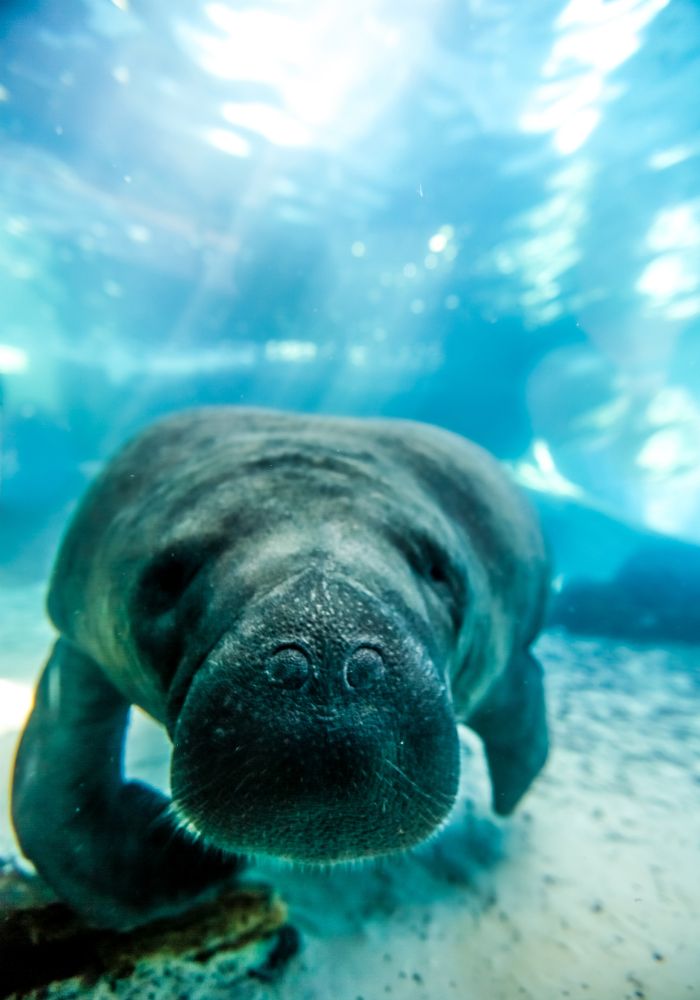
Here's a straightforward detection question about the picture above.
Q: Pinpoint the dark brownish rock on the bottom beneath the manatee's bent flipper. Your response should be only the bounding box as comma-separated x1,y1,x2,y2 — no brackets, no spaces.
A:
0,864,298,1000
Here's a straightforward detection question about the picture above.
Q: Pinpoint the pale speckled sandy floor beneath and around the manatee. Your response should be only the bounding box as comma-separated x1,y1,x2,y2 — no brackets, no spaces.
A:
0,587,700,1000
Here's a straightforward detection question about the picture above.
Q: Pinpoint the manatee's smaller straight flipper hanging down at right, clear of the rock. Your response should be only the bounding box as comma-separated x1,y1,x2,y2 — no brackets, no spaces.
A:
469,650,549,816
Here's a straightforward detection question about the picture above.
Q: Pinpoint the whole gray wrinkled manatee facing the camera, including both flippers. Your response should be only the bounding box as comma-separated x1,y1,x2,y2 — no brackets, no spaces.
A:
12,407,547,928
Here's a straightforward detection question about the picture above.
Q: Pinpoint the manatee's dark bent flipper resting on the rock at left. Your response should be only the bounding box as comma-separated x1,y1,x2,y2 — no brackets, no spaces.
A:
12,639,240,929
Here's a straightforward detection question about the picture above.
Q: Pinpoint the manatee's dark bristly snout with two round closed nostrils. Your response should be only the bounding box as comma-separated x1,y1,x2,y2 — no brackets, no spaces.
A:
172,571,458,863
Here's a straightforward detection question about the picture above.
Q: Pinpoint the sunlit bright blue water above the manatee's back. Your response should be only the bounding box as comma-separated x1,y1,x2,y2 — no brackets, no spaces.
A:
0,0,700,580
